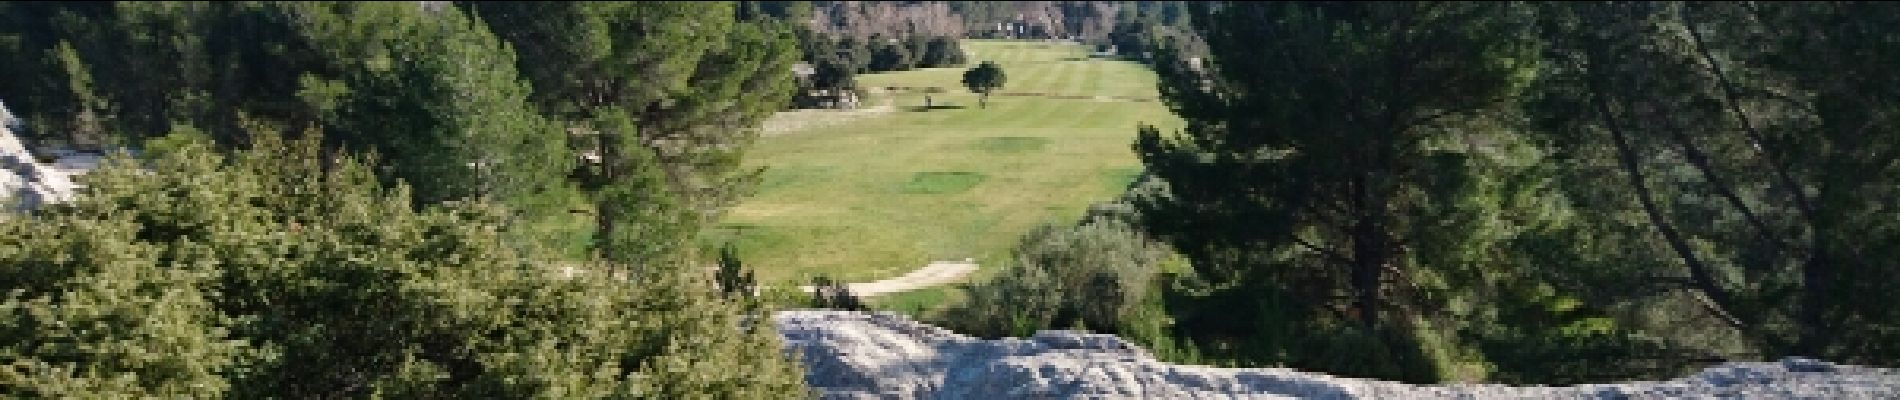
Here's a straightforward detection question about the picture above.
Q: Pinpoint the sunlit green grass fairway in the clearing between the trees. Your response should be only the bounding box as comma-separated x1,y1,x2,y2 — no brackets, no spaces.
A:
711,40,1180,282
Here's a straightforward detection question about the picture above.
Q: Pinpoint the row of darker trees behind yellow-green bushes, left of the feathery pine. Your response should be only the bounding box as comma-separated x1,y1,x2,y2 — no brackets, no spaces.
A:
0,2,572,234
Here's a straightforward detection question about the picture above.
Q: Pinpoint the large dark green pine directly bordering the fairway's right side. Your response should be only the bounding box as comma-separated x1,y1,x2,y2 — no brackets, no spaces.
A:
1136,2,1533,381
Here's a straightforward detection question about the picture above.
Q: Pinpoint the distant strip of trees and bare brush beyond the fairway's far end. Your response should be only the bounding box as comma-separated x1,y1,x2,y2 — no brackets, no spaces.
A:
741,2,1205,108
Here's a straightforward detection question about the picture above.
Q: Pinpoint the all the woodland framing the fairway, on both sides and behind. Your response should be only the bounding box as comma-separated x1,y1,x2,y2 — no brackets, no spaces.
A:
0,2,1900,398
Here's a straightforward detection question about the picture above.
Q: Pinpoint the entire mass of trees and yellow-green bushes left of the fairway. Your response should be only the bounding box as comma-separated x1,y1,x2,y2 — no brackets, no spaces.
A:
0,2,804,398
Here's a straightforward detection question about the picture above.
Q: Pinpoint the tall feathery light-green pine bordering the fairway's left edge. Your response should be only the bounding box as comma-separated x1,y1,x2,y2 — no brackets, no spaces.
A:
471,2,798,265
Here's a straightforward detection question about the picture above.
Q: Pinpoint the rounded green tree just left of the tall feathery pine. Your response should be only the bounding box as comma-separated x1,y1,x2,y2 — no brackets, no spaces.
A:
300,4,572,205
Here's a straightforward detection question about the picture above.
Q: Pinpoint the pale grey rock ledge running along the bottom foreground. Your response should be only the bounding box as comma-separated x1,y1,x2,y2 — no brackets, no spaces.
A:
773,311,1900,400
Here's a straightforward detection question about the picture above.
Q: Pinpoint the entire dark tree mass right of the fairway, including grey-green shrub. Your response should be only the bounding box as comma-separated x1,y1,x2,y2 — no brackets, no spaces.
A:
942,2,1900,383
